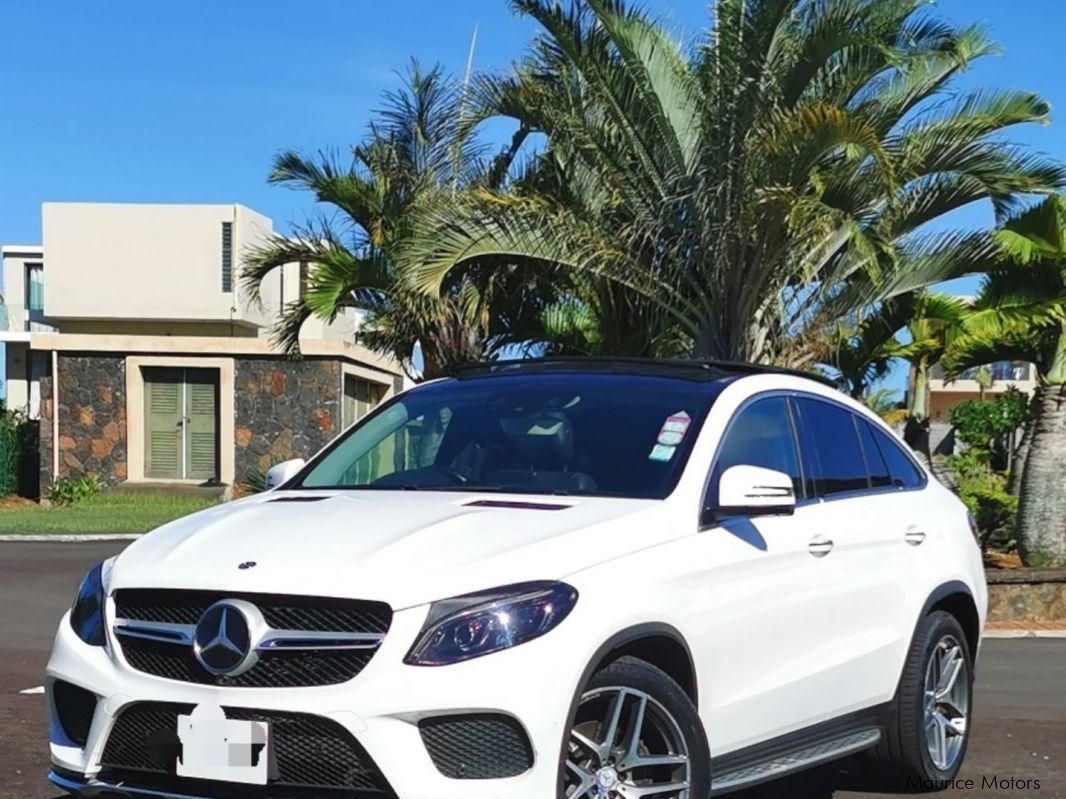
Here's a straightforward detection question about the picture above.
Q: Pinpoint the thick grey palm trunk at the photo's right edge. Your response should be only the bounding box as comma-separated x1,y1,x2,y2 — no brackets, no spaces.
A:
1017,384,1066,566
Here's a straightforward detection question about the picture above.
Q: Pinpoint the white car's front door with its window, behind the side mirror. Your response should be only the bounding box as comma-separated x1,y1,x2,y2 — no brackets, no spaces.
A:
695,395,840,755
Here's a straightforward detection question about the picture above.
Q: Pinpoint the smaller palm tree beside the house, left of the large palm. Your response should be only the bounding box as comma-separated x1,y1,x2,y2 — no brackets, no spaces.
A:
242,62,552,377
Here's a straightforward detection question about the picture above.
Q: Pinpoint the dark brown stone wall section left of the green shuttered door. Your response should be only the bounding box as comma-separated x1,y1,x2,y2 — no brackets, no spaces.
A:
48,354,127,490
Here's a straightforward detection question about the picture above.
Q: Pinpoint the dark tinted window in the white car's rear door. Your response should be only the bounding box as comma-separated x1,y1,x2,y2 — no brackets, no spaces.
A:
794,397,870,496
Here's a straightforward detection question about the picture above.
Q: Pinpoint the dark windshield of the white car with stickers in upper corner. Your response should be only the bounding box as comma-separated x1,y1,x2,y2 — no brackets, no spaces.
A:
296,374,715,499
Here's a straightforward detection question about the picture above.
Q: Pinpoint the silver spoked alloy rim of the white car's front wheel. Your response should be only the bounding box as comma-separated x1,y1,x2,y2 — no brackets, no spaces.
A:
563,687,692,799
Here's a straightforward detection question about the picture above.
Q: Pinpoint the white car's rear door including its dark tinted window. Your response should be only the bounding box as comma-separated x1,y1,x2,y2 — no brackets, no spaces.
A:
792,396,912,718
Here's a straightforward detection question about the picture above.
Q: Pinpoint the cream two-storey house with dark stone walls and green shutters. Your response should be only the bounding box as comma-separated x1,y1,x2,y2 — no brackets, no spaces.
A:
0,202,403,486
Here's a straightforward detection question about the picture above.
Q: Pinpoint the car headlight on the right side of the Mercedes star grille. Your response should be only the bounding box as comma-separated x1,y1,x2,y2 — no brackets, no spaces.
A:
404,582,578,666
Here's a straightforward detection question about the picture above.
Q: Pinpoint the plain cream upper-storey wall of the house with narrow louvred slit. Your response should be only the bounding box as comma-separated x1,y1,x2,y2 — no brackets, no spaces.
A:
42,202,277,329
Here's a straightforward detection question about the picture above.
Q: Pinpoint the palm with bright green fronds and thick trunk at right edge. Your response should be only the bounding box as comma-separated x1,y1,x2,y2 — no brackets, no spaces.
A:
944,197,1066,565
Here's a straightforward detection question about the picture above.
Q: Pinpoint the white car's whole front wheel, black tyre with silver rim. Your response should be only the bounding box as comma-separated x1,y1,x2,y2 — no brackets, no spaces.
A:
560,657,711,799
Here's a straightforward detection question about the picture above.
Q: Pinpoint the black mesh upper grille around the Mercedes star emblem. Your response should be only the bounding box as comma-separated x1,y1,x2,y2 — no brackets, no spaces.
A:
115,588,392,688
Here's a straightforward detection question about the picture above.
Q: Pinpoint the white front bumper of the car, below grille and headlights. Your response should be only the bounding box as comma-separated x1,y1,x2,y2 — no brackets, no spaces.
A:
46,607,584,799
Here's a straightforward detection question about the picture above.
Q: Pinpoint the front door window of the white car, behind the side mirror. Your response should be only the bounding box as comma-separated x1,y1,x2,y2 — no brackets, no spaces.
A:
712,396,803,496
